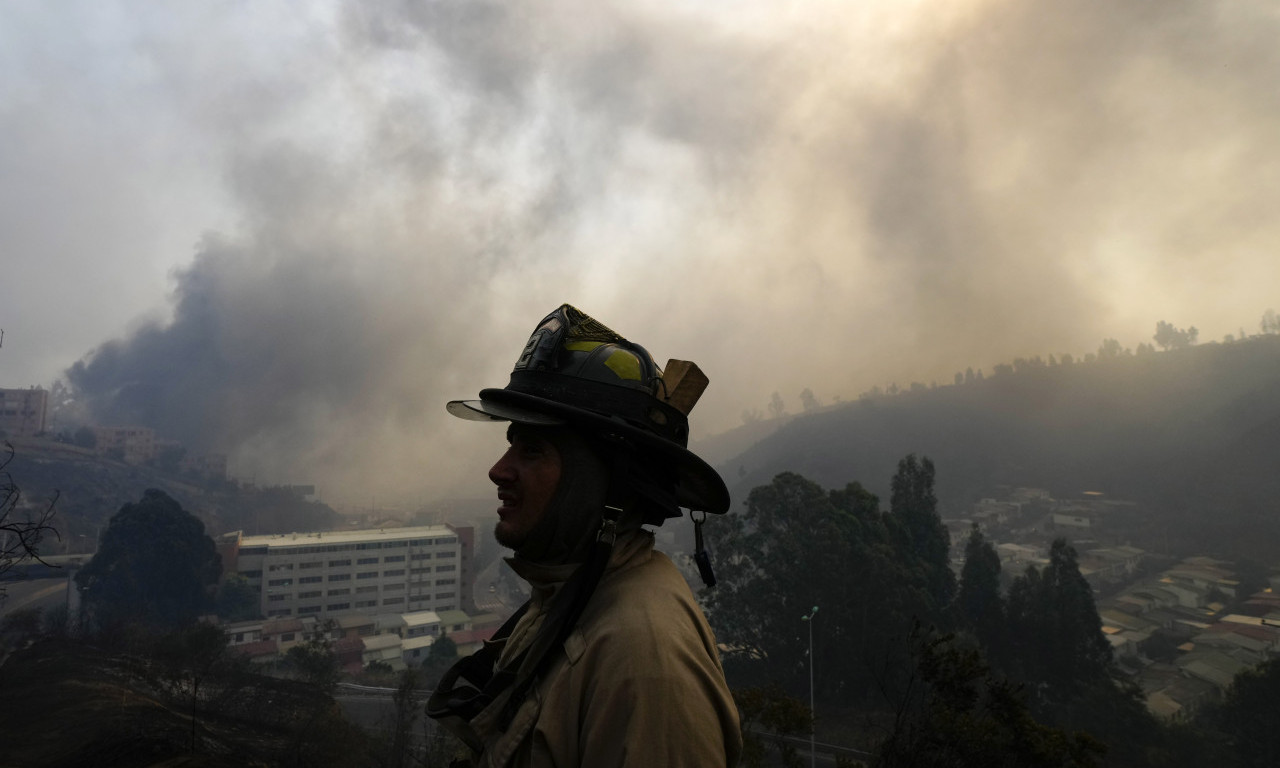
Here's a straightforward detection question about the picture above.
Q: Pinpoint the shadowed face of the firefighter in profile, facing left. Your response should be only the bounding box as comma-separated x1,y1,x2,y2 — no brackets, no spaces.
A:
489,424,561,549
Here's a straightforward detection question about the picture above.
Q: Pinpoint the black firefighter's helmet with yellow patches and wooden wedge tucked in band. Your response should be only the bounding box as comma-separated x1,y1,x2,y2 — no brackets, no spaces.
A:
445,305,728,513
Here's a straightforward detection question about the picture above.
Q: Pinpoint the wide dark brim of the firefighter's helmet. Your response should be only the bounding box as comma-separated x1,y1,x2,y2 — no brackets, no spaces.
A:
445,389,730,515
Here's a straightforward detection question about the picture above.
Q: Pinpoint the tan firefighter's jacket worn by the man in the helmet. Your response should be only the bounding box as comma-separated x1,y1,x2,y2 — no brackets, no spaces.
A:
460,531,742,768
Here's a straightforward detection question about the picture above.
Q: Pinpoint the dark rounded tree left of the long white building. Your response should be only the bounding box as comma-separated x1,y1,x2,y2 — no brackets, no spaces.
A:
76,489,221,630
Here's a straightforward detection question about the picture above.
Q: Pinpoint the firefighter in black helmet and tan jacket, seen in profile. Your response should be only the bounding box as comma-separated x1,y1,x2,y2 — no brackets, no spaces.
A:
428,305,742,768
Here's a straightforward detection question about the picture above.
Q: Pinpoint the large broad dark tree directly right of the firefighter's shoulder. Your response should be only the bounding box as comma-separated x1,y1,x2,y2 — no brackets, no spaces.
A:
703,472,931,700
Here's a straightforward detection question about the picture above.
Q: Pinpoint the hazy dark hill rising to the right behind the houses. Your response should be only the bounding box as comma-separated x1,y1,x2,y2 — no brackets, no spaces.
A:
721,335,1280,545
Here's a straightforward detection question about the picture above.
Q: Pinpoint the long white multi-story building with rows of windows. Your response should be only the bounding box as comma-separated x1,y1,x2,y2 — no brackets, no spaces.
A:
225,525,470,618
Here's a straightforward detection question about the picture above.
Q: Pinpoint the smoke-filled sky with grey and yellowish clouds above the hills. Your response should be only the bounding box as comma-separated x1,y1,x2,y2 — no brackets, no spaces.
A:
0,0,1280,499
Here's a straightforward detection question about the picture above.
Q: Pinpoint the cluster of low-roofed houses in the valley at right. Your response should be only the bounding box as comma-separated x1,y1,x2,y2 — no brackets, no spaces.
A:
943,488,1280,719
